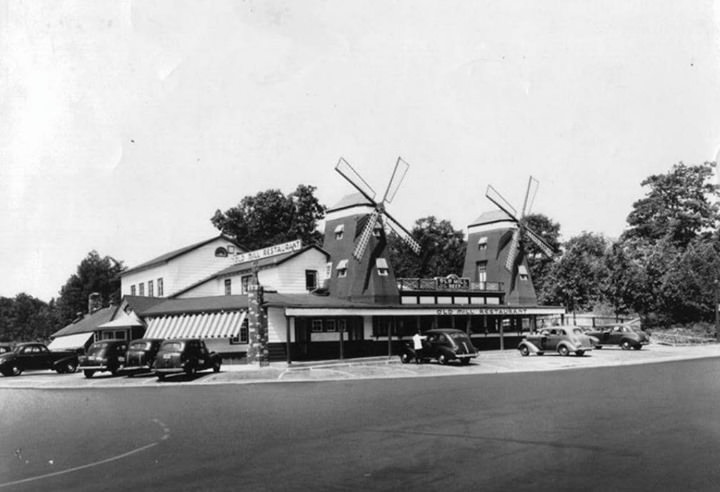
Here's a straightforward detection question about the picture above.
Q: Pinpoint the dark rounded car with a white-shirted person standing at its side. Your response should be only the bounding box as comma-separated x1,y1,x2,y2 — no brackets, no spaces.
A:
400,328,477,364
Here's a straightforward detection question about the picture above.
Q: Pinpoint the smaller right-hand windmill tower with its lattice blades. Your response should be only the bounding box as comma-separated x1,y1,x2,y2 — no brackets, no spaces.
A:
463,176,554,305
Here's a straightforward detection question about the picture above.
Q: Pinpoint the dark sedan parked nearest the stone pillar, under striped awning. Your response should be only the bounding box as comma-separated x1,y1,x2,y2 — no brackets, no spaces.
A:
155,338,222,381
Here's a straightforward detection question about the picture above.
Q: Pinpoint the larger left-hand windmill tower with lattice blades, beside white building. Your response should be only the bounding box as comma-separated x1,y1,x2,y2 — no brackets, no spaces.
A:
323,158,420,303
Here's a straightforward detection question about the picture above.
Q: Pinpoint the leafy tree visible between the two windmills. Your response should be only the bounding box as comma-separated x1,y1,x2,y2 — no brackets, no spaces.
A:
388,216,467,278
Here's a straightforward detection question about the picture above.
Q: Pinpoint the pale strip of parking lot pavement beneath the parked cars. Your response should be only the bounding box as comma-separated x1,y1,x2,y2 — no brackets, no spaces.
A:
0,343,720,389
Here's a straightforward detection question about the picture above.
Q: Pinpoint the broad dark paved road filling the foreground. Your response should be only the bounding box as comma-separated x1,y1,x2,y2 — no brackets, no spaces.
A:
0,350,720,490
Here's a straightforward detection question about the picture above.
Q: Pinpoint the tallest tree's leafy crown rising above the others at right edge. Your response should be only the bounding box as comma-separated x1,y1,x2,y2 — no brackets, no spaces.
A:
622,162,718,247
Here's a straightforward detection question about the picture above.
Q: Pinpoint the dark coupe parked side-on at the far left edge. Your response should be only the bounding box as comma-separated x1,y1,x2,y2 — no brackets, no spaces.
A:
0,342,78,376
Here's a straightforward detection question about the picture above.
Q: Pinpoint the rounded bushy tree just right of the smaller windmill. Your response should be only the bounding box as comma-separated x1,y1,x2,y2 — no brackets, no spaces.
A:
540,232,609,311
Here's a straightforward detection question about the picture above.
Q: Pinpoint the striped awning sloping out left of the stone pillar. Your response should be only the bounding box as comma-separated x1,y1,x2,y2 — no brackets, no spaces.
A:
144,311,247,338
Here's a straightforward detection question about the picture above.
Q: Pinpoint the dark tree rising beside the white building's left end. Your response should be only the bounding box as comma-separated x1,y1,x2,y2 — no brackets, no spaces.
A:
57,250,125,325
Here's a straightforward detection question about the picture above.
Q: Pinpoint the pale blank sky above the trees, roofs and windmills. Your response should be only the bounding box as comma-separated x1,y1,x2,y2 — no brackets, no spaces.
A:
0,0,720,301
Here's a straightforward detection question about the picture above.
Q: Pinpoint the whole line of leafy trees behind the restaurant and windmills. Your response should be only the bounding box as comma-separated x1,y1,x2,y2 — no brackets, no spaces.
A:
0,162,720,341
